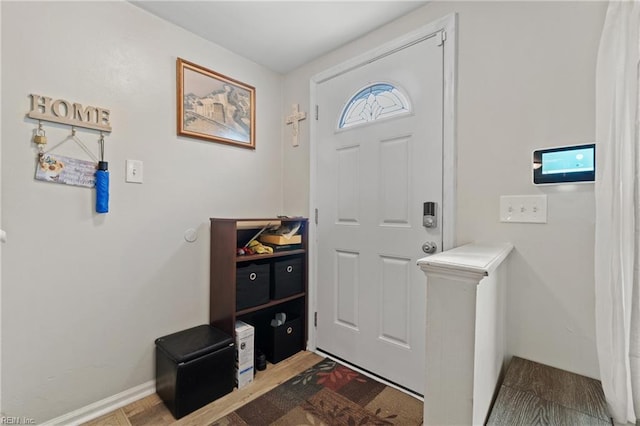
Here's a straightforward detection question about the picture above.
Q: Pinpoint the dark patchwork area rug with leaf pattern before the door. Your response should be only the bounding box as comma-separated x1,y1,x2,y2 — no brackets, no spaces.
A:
213,358,423,426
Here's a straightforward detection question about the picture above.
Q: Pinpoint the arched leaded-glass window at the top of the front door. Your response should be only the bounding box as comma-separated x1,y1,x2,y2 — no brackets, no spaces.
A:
338,83,411,129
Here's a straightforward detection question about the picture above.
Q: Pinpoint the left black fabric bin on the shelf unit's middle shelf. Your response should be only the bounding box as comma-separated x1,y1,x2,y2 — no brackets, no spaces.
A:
236,263,269,311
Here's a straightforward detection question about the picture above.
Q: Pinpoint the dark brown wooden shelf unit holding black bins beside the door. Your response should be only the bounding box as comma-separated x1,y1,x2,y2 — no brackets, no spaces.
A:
209,218,309,349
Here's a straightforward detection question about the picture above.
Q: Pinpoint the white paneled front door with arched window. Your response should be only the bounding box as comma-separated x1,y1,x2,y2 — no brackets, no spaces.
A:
316,33,446,394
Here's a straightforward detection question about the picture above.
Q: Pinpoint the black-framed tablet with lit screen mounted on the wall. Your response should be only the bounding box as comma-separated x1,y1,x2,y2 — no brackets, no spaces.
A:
533,143,596,185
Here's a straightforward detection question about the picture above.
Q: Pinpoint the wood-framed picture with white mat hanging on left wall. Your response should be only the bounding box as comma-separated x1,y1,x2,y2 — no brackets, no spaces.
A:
177,58,256,149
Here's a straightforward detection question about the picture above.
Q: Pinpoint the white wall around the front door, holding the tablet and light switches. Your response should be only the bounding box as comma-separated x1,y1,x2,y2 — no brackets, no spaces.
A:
283,2,606,377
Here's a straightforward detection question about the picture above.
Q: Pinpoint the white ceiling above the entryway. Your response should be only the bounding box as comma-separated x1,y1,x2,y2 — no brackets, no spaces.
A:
130,0,427,74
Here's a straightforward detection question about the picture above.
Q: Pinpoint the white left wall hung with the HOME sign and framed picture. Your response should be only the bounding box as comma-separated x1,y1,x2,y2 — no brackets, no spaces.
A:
1,2,282,421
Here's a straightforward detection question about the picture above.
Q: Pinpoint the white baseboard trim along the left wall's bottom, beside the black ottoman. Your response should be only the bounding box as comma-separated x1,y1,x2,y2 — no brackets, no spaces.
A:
42,380,156,426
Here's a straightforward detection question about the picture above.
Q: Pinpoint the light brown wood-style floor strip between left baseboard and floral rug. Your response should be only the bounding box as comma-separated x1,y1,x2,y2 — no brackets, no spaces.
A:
85,351,323,426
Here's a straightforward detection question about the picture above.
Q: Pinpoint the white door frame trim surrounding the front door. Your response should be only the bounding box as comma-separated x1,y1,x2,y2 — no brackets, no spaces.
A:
307,13,458,351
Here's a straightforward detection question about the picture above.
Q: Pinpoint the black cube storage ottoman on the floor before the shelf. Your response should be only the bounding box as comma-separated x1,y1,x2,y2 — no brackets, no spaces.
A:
155,324,235,419
